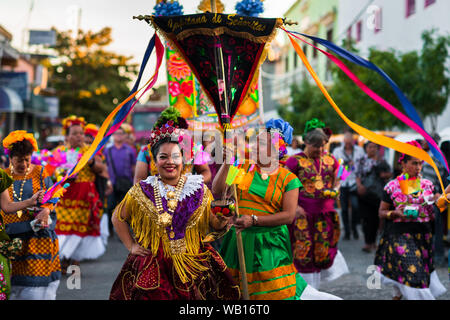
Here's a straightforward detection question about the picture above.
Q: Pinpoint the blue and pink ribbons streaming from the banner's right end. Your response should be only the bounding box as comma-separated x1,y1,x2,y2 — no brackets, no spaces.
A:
282,28,450,172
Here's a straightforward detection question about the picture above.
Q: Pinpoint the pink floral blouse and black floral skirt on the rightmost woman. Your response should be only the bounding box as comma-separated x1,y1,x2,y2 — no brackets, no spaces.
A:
375,179,445,298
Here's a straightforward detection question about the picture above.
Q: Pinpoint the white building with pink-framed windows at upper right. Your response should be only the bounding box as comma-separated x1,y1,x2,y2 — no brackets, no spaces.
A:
335,0,450,132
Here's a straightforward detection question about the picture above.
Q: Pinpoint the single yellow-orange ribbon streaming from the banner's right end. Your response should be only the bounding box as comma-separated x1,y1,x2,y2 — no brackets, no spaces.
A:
287,33,445,198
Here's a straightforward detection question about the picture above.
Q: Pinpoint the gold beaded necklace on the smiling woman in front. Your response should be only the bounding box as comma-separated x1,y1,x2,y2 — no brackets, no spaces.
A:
154,176,186,239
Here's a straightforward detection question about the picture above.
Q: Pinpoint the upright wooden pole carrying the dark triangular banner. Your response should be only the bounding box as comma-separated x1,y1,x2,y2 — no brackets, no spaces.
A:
211,0,250,300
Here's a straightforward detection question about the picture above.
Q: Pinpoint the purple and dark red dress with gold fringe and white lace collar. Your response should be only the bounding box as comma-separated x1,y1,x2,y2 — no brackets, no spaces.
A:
110,174,240,300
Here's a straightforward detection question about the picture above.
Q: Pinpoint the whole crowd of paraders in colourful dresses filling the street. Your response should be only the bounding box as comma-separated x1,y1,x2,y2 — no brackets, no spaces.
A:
0,107,450,300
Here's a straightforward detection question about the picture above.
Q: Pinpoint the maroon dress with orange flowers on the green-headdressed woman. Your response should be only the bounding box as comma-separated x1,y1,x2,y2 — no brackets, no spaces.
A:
286,152,340,281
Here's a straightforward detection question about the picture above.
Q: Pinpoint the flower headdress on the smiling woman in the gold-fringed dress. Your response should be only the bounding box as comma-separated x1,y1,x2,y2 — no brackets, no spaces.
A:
149,107,188,148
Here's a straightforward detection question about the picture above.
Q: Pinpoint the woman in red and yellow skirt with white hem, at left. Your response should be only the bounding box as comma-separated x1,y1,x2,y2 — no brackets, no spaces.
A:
55,116,105,274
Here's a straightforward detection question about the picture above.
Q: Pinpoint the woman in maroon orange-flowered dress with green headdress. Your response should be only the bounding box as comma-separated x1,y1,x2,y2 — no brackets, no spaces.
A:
286,119,349,289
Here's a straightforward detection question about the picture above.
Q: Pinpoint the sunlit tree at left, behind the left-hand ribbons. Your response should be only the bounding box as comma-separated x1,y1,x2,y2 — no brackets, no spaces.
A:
46,27,137,124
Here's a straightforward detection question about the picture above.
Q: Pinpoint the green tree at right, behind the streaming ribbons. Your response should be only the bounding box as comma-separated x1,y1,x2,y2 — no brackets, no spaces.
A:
279,30,450,132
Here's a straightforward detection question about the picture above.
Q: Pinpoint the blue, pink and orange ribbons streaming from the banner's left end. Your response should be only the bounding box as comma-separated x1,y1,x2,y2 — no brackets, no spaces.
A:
42,33,164,204
